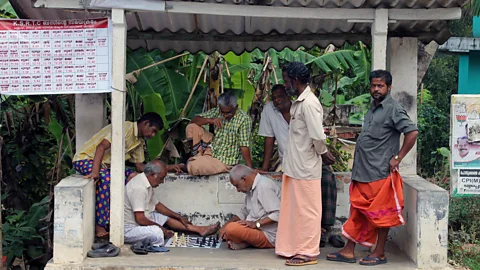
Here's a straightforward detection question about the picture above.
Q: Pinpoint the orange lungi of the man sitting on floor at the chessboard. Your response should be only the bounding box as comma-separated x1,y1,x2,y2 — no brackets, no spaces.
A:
225,222,273,248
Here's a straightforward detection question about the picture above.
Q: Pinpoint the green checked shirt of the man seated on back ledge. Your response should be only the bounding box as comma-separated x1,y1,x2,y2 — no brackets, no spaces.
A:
199,108,252,166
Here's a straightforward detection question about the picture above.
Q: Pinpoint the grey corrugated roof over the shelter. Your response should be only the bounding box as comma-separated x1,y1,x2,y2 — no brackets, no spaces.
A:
11,0,468,54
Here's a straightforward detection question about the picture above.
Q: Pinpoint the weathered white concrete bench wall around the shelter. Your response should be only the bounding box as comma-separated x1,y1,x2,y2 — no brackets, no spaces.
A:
53,173,448,269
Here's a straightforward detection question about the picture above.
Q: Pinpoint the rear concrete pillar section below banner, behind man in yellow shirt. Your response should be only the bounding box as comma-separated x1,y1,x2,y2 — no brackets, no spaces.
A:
75,94,107,152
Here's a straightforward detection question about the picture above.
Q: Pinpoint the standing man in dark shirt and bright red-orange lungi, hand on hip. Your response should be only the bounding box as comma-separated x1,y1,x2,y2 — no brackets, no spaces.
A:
327,70,418,265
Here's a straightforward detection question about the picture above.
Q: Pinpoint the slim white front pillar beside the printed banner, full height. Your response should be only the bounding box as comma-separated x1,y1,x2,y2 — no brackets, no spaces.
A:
110,9,127,246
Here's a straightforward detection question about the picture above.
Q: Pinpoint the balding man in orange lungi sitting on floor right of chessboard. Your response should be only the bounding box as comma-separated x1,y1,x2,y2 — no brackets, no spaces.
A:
219,165,280,250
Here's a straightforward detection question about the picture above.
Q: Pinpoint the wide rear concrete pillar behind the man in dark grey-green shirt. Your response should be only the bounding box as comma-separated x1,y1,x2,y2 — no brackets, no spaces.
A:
388,38,418,174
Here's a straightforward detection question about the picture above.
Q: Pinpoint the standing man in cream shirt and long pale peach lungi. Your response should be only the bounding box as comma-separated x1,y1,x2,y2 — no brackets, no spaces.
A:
275,62,334,266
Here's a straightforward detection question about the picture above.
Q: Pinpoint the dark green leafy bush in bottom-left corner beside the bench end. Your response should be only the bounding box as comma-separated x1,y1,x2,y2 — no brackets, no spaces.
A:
2,197,50,266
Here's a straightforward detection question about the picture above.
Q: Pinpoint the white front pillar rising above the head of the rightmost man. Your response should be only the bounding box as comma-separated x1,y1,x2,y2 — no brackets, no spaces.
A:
371,9,388,70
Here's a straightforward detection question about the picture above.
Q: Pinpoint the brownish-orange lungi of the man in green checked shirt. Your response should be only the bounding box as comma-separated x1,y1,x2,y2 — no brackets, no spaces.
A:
185,124,228,175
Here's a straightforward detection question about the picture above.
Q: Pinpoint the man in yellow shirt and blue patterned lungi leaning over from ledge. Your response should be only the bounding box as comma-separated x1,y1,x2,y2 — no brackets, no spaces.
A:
72,112,164,238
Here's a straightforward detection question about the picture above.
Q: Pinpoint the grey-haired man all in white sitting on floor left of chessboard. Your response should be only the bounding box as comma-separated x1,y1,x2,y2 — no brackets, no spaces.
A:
124,160,219,246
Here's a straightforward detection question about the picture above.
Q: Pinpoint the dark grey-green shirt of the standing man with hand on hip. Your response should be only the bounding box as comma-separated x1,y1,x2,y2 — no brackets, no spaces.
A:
352,94,418,183
